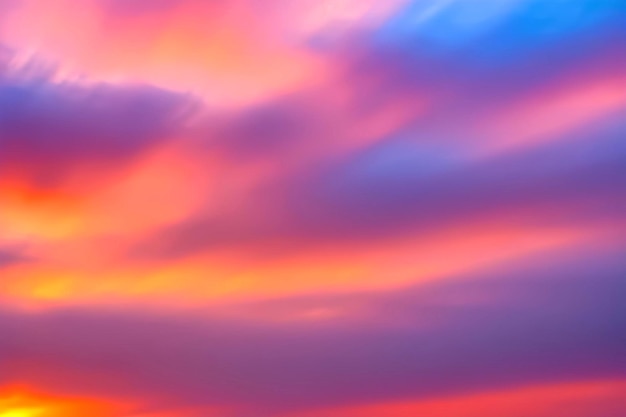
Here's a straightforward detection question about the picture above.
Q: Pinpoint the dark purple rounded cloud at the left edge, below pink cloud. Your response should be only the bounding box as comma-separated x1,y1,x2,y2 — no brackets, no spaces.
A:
0,54,193,185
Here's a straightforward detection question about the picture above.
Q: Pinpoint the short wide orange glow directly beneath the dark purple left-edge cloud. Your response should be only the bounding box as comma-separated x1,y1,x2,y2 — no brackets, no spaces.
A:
0,142,205,242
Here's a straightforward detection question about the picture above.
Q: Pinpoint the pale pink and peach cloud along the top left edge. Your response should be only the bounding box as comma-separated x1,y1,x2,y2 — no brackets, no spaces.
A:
4,0,332,106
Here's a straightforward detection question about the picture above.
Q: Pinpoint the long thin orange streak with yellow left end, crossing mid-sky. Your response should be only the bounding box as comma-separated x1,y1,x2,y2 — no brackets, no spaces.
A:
0,224,595,307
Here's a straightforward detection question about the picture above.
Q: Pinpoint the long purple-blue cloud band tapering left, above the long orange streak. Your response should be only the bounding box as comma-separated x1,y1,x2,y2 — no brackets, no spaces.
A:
131,110,626,260
